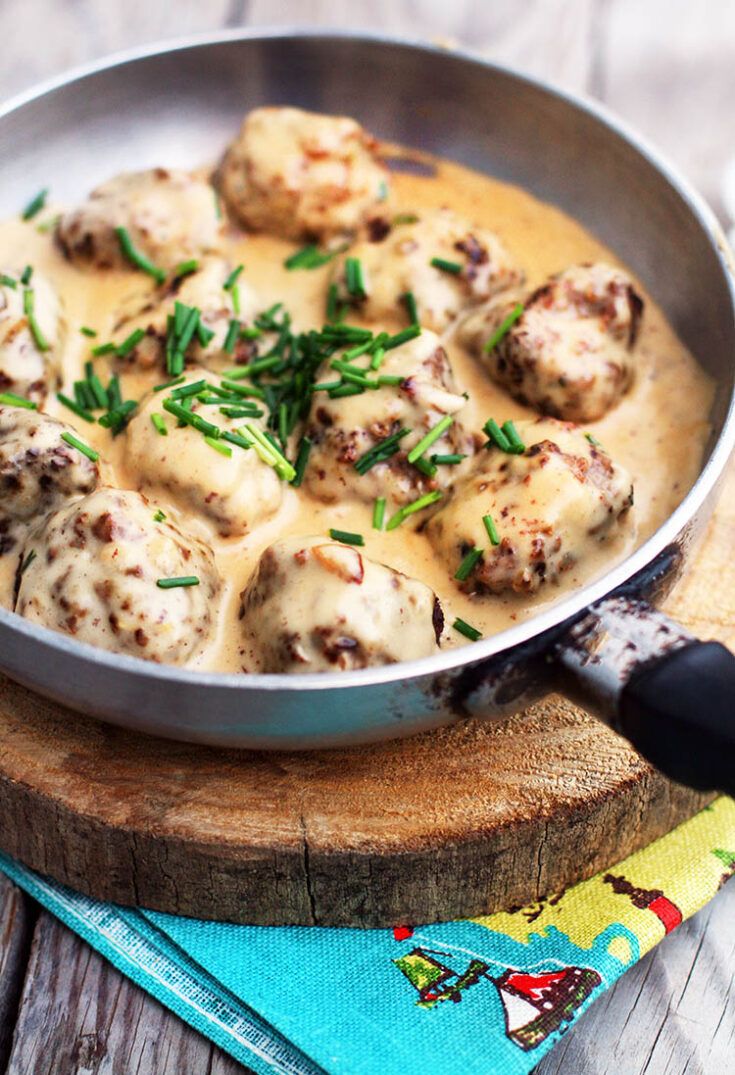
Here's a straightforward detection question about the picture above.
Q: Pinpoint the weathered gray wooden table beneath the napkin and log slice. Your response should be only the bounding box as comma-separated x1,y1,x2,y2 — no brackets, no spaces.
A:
0,0,735,1075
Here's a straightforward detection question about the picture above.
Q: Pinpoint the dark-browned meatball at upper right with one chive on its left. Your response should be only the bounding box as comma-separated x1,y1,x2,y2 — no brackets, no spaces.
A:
459,263,644,421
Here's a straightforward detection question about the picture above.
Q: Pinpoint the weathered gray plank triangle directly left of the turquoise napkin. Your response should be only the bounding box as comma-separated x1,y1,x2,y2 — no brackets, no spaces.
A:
8,912,247,1075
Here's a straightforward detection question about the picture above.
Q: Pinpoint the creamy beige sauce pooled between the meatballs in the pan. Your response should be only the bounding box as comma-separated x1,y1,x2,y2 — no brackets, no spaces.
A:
0,161,714,671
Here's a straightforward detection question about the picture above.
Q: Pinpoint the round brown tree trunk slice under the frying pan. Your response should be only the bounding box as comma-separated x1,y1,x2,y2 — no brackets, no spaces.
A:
0,471,735,926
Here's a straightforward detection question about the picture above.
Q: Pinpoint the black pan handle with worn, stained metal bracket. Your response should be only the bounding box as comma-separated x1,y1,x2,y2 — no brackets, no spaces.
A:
554,597,735,794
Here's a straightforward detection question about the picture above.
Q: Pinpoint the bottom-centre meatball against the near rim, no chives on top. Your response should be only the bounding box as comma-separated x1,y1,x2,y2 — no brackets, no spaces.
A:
240,538,444,672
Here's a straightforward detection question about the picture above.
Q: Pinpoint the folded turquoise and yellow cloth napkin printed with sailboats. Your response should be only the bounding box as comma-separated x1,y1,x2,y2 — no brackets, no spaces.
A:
0,798,735,1075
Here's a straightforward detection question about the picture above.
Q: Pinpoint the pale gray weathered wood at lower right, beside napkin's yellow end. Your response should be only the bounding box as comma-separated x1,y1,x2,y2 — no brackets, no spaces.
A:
535,884,735,1075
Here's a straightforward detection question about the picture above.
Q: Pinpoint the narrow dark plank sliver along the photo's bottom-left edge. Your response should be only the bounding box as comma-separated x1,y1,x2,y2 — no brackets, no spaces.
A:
0,874,35,1071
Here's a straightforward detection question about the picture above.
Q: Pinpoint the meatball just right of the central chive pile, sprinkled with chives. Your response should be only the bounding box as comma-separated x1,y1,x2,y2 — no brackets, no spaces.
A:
305,329,473,509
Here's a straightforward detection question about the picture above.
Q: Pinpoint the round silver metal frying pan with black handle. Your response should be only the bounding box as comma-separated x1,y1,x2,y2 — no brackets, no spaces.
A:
0,31,735,791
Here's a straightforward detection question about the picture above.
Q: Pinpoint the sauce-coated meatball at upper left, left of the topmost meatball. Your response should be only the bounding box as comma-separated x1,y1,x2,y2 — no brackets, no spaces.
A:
56,168,222,269
